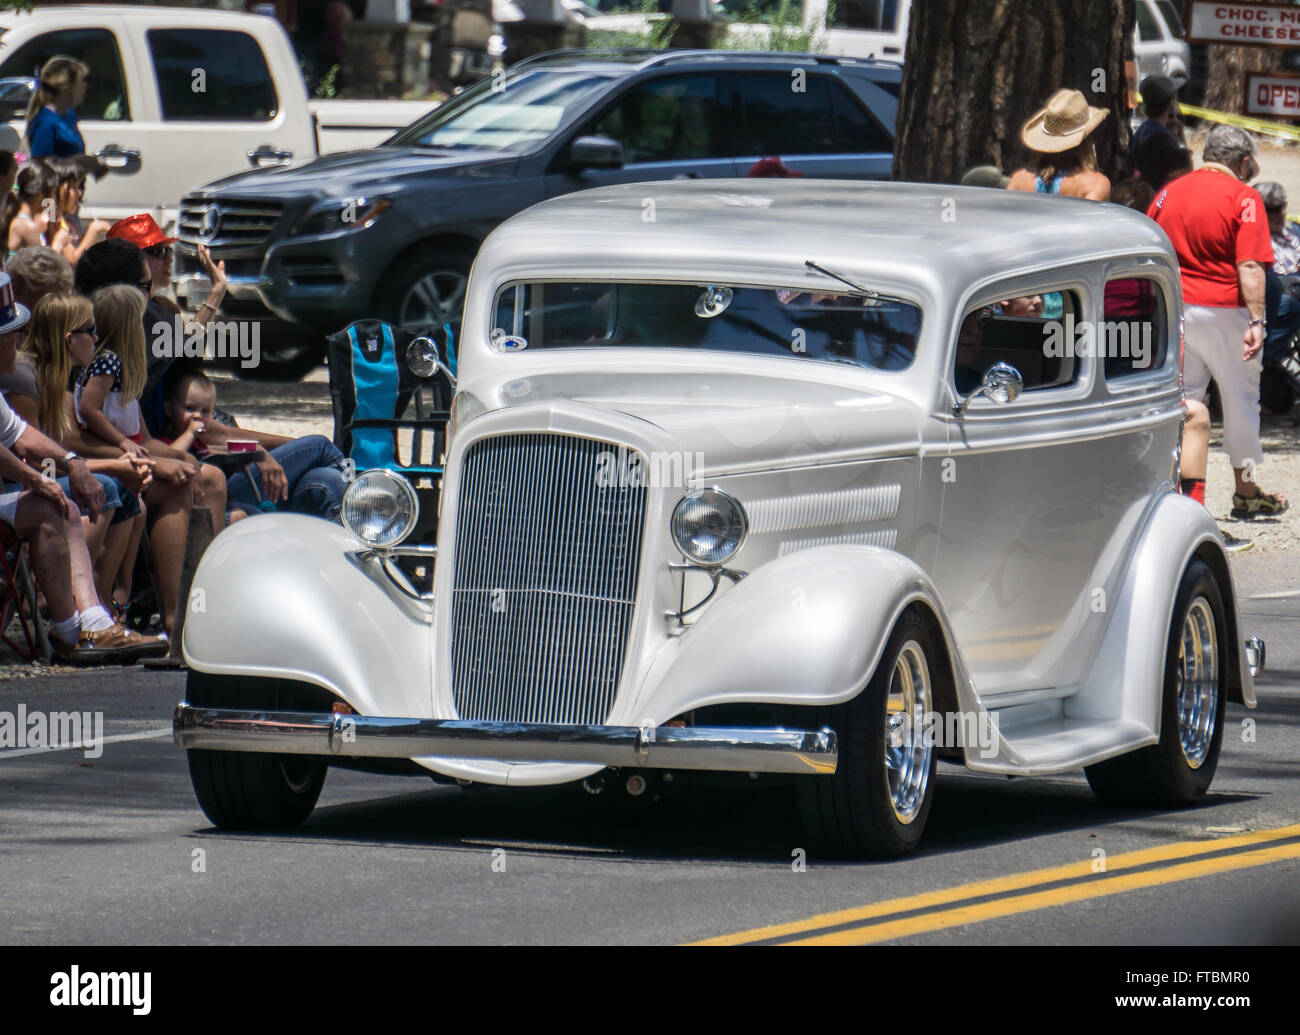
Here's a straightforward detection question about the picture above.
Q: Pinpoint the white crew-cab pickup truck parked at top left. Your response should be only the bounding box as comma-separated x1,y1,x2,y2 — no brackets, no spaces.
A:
0,5,434,226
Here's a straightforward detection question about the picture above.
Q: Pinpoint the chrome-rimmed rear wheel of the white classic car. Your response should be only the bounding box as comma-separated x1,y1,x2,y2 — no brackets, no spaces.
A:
1084,560,1229,809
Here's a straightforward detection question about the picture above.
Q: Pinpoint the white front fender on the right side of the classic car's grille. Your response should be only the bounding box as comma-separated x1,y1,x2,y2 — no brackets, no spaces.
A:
636,546,969,722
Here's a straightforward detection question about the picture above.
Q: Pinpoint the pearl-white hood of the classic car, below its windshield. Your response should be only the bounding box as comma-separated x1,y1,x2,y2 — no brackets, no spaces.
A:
478,372,923,476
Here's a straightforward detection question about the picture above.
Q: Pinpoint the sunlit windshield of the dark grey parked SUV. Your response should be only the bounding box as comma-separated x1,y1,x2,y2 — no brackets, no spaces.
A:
387,69,610,151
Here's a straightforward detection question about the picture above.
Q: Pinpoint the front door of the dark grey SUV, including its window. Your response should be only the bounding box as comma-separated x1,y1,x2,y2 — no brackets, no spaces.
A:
546,73,736,198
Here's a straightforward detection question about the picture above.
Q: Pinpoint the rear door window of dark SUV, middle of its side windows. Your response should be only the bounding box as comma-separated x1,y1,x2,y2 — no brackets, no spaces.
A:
738,73,837,155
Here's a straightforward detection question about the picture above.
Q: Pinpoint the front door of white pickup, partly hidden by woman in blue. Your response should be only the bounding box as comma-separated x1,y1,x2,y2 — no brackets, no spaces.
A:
0,14,155,220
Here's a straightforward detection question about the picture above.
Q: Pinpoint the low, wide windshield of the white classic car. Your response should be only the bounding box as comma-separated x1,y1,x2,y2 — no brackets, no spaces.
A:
491,281,920,371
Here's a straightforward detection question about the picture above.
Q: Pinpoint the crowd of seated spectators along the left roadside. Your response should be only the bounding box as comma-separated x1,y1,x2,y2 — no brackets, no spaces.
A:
0,57,346,664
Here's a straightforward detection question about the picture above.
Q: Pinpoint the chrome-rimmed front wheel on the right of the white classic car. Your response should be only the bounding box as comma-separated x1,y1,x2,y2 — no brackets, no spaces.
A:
798,610,940,858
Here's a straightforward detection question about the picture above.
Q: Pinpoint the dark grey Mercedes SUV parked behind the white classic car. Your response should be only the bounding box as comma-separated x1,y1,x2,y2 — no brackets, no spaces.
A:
174,51,901,377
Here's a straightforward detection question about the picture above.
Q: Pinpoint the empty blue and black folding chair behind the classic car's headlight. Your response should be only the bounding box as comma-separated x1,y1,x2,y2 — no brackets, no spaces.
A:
326,320,456,585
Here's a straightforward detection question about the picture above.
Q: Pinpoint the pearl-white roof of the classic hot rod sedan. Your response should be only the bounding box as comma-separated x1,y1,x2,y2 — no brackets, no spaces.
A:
480,178,1178,298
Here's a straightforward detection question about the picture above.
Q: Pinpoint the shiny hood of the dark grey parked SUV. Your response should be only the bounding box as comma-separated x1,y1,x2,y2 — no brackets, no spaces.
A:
195,147,517,202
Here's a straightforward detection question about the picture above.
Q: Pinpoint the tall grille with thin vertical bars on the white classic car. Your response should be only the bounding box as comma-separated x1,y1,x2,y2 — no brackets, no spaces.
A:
451,434,646,724
